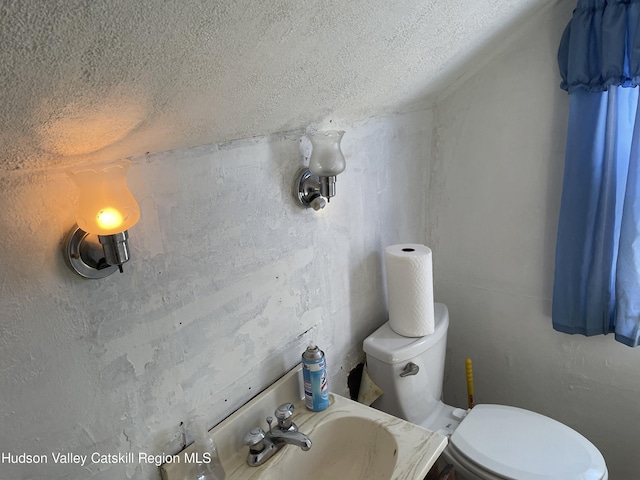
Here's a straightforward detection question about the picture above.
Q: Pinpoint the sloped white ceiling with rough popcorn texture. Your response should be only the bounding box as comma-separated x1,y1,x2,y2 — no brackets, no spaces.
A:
0,0,549,171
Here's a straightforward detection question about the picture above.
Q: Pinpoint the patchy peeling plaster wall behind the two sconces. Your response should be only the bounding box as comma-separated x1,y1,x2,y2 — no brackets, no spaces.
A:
0,110,432,480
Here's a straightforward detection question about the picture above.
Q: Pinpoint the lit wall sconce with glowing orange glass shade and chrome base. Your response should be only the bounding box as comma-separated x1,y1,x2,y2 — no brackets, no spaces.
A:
65,160,140,279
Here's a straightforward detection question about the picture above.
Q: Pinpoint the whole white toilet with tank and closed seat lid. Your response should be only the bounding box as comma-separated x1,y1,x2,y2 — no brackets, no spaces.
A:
363,303,609,480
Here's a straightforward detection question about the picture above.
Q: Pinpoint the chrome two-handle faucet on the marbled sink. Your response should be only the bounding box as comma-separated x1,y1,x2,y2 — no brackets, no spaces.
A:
244,403,311,467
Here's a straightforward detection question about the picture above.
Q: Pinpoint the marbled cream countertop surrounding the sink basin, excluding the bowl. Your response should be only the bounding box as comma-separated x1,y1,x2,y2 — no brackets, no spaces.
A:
160,365,447,480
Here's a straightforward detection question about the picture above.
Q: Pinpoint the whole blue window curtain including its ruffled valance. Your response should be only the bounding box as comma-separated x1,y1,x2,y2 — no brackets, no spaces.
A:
552,0,640,346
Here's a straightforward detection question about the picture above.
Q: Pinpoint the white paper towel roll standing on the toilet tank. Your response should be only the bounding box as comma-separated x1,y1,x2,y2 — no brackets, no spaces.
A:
385,244,435,337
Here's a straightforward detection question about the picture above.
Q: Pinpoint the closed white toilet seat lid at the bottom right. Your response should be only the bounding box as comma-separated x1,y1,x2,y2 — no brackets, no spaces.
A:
447,405,608,480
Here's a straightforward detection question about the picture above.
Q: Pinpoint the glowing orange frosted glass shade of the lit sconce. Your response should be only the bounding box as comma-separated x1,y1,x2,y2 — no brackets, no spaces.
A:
69,160,140,235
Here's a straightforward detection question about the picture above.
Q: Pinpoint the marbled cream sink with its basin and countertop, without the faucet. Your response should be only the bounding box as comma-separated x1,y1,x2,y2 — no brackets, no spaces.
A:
161,367,447,480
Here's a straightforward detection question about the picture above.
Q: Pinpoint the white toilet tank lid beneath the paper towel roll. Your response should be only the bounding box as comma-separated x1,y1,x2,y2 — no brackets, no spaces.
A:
362,303,449,364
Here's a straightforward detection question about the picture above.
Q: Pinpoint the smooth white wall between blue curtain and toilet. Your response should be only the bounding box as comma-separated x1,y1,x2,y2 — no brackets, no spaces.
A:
428,1,640,480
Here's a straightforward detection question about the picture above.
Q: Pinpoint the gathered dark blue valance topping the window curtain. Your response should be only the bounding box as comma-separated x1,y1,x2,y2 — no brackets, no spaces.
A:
558,0,640,93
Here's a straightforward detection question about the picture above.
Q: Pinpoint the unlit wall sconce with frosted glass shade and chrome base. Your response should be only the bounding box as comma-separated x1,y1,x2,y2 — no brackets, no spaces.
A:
293,130,346,211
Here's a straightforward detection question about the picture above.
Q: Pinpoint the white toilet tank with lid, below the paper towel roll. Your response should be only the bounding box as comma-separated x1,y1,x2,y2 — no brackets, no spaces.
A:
363,303,449,425
